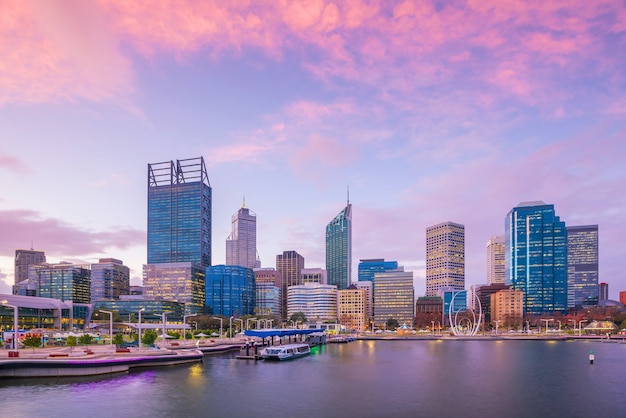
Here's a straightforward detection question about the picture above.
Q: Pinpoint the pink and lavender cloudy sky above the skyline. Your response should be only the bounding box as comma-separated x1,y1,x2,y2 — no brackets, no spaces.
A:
0,0,626,299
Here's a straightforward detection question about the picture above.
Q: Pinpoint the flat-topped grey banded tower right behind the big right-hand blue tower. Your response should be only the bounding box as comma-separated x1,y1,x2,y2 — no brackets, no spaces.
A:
567,225,598,308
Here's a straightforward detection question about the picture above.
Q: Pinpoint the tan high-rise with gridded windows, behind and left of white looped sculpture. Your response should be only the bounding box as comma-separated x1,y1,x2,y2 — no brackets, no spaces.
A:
426,222,465,296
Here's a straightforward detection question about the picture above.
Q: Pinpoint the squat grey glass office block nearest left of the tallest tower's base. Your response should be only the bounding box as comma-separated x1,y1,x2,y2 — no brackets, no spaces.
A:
91,258,130,302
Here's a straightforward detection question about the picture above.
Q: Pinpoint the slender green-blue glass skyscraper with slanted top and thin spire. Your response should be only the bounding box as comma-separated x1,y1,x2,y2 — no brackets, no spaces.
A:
326,202,352,289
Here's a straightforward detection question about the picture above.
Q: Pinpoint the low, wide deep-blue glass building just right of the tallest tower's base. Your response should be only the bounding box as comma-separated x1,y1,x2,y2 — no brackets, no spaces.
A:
205,264,256,316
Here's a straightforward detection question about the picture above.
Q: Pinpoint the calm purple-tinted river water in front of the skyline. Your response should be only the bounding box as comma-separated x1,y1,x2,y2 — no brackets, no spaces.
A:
0,340,626,418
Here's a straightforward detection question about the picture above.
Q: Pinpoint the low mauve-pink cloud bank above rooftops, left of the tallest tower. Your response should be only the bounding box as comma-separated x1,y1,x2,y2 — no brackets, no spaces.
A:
0,209,145,257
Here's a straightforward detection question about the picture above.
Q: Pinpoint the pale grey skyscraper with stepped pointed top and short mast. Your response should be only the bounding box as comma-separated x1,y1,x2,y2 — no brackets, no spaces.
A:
226,201,261,269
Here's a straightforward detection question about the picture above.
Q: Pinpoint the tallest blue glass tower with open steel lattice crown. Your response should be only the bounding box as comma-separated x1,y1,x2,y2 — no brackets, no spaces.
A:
148,157,211,267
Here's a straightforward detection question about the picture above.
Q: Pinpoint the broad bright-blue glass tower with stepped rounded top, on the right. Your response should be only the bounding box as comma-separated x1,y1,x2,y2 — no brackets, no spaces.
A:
504,202,567,314
